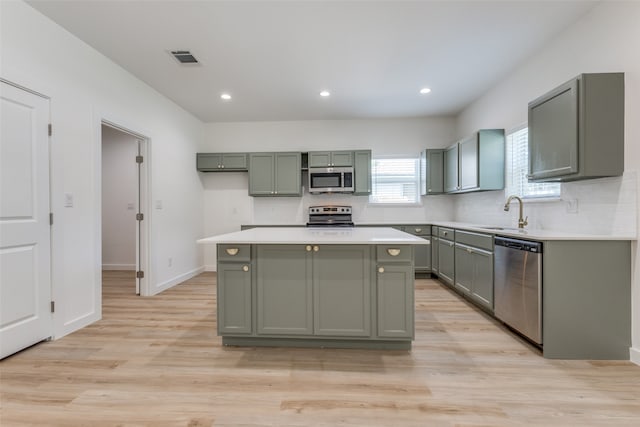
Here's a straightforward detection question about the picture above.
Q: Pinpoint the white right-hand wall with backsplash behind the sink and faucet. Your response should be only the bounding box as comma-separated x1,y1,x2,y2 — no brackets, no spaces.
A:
456,2,640,364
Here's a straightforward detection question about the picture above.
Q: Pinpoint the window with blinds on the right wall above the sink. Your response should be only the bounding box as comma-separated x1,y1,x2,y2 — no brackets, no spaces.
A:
505,126,560,199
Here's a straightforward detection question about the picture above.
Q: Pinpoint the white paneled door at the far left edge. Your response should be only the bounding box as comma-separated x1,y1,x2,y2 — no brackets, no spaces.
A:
0,82,53,358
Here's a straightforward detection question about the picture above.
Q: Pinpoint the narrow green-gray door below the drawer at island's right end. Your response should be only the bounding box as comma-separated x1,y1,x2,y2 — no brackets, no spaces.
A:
376,264,414,338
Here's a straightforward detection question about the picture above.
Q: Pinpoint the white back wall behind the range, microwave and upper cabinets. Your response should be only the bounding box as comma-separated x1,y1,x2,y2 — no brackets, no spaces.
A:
200,117,455,270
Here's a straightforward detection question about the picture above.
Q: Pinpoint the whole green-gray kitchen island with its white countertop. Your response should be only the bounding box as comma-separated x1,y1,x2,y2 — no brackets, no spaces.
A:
198,227,429,349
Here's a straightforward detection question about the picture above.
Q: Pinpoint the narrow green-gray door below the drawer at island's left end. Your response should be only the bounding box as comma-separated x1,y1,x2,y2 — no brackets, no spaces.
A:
217,263,252,335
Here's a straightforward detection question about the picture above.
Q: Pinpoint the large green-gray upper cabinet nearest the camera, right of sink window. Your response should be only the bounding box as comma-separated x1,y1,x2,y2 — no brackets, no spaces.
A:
527,73,624,182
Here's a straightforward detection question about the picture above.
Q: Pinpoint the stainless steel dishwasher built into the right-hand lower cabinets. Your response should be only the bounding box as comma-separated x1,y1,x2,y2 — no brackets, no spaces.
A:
494,236,542,345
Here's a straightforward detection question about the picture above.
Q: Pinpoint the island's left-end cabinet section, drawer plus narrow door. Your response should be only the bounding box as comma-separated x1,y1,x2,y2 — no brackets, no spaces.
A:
217,245,253,335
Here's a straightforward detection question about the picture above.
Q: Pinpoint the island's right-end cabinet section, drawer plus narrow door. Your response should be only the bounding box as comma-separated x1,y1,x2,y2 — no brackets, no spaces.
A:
376,245,415,338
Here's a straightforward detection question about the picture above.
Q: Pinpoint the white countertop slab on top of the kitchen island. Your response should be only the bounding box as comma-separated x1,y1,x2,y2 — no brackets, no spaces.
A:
198,227,430,245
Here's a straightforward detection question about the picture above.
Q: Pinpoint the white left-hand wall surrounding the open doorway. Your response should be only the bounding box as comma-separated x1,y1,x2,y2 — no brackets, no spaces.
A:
0,1,203,337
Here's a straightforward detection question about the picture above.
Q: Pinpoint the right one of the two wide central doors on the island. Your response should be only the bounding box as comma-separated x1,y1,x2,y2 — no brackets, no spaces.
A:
313,245,371,337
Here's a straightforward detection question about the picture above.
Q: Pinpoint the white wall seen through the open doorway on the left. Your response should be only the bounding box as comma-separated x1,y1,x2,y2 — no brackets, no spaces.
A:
102,126,138,270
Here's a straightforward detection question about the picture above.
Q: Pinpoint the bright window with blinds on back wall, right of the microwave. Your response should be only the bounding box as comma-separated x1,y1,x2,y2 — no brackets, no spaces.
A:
369,158,420,204
